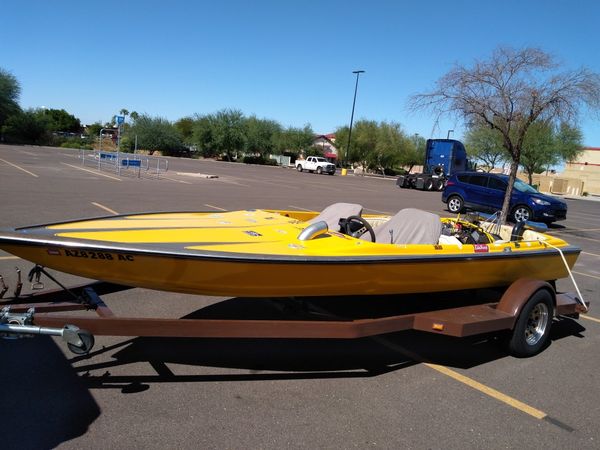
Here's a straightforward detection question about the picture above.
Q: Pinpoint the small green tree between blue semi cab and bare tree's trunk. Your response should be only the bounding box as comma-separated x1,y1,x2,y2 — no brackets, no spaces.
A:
465,124,510,172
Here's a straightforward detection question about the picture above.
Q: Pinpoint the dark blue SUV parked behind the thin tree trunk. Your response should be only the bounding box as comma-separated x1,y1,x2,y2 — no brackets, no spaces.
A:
442,172,567,224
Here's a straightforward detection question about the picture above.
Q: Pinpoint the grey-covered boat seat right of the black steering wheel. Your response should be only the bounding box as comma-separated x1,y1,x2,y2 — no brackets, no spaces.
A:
374,208,442,245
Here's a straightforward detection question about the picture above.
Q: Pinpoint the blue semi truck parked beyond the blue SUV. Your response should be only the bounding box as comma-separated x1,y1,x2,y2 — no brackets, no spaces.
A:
396,139,471,191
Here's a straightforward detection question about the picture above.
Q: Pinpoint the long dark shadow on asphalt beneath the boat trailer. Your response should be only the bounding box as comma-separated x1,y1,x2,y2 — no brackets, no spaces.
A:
65,296,584,393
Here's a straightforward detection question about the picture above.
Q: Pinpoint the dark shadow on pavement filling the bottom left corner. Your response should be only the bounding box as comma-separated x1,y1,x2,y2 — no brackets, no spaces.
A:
0,337,101,449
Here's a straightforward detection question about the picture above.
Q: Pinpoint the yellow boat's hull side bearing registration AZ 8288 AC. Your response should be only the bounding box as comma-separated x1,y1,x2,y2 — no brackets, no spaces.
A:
2,241,579,297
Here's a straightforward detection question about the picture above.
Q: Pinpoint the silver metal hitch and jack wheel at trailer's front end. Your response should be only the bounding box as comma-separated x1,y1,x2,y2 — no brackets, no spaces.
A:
0,306,94,355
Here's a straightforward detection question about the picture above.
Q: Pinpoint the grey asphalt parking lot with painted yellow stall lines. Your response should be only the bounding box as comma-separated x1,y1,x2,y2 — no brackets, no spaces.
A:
0,145,600,449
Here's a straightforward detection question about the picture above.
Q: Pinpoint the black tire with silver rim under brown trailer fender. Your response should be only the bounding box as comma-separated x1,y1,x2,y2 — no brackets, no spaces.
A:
508,289,554,358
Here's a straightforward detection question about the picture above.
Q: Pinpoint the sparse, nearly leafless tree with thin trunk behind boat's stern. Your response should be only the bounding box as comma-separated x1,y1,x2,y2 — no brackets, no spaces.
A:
409,47,600,222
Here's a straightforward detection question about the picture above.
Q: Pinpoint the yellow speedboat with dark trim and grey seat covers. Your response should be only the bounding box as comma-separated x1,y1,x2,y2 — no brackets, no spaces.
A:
0,203,580,297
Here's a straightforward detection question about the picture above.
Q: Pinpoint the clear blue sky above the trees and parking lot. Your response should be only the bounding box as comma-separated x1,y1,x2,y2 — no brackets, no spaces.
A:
0,0,600,147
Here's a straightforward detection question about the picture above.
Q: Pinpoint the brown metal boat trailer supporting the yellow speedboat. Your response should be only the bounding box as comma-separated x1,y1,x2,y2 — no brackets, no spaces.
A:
0,265,588,356
